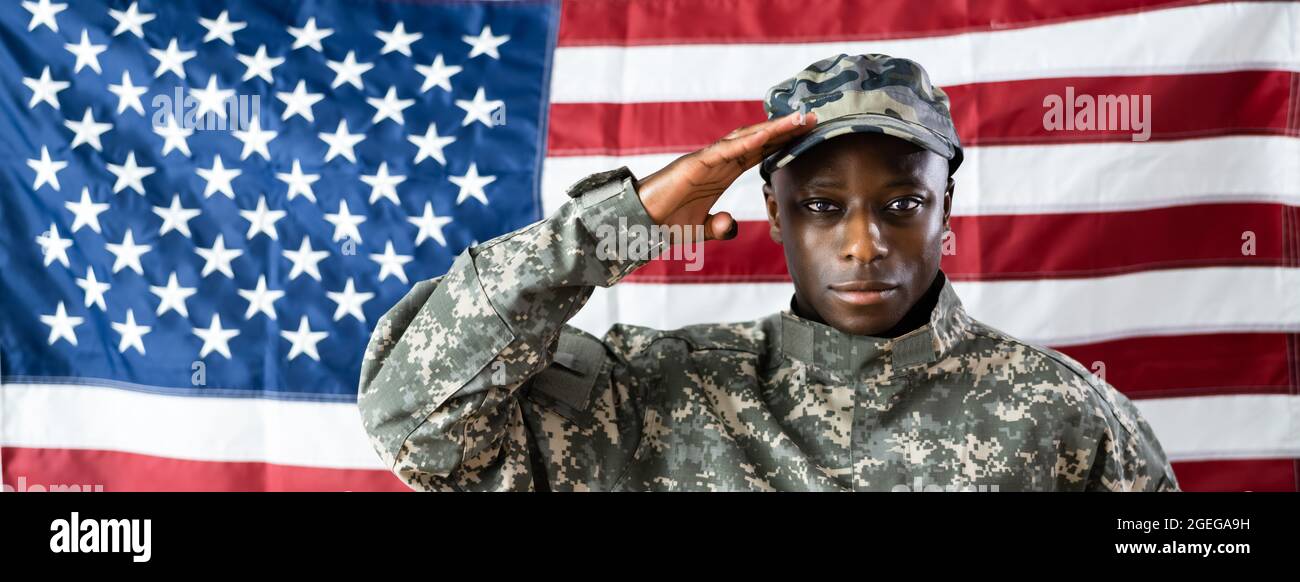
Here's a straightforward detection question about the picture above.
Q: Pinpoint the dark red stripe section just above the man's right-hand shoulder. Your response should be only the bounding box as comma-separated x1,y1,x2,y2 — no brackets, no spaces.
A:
1057,334,1291,399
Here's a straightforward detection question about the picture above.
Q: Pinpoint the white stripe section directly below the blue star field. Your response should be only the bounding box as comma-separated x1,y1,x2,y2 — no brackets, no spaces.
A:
0,383,386,470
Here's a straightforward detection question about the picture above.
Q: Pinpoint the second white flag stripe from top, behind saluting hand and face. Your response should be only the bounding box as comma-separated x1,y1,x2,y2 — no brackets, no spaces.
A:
542,136,1300,221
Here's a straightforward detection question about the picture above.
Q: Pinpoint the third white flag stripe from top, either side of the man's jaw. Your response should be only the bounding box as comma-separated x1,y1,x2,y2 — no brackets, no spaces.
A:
571,267,1300,346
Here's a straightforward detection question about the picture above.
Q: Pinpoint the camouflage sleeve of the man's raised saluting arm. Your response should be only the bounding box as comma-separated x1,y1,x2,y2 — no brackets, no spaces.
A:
358,166,654,491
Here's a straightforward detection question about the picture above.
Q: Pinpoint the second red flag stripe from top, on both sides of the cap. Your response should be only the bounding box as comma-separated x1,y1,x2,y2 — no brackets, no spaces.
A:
547,70,1300,156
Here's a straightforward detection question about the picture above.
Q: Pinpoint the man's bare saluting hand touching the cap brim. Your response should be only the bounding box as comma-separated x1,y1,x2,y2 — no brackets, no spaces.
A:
636,112,816,243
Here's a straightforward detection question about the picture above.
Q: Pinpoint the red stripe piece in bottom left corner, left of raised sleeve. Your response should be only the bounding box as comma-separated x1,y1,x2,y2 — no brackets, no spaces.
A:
0,447,411,491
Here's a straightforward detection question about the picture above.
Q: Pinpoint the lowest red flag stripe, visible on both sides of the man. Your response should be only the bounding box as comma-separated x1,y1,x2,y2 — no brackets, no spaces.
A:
0,447,1296,492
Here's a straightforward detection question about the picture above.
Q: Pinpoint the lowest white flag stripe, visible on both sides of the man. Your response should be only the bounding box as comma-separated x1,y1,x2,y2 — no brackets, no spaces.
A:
3,385,1300,469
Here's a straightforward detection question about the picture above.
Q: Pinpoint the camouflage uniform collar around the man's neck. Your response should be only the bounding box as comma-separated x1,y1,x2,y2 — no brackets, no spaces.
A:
780,272,970,373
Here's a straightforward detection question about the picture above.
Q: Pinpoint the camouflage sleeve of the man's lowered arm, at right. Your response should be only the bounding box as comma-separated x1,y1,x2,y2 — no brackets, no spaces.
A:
1086,385,1180,491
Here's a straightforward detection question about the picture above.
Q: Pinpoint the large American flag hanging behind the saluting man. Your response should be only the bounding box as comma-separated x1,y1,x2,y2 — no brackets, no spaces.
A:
0,0,1300,491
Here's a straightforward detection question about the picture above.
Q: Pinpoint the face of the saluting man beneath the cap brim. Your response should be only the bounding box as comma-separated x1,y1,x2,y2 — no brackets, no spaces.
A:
763,129,953,335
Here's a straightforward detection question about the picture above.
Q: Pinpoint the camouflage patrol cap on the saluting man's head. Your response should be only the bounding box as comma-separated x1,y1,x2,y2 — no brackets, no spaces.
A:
759,55,962,181
